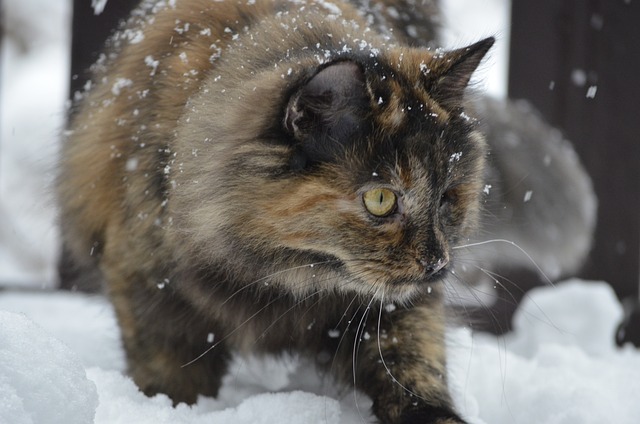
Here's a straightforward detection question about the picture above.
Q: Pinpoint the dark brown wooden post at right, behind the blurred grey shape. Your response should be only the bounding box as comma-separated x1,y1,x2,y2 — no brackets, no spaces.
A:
509,0,640,298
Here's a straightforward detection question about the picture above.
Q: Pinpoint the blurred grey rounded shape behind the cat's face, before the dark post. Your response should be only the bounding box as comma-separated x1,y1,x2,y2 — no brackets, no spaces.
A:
458,97,597,280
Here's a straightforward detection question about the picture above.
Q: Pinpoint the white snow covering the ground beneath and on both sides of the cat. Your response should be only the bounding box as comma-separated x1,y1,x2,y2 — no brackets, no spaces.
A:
0,280,640,424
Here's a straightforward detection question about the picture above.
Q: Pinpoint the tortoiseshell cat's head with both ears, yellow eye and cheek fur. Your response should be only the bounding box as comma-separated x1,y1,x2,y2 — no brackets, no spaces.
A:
173,39,493,301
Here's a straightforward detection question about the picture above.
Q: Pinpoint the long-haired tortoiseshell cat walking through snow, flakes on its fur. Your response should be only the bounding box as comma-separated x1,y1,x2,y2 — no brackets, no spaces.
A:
58,0,596,424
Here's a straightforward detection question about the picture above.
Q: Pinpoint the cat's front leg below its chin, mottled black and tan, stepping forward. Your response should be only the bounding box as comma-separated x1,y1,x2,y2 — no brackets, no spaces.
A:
356,301,464,424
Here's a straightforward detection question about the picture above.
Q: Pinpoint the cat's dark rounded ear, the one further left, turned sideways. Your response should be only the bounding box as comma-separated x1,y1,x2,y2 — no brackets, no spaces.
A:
284,61,368,162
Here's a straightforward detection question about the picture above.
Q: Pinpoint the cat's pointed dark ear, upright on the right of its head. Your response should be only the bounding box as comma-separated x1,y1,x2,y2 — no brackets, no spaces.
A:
426,37,495,110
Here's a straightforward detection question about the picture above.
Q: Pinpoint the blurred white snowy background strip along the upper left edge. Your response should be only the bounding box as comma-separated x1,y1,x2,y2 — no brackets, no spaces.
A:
0,0,70,287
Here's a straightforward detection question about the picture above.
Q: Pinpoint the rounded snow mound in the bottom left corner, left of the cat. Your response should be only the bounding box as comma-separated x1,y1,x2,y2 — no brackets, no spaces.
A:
0,311,98,424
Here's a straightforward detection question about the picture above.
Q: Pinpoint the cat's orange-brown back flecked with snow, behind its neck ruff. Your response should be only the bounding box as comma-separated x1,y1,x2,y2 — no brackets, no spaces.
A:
58,0,376,264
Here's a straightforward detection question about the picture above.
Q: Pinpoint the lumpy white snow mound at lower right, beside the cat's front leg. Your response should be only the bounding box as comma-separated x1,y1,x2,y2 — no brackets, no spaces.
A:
449,280,640,424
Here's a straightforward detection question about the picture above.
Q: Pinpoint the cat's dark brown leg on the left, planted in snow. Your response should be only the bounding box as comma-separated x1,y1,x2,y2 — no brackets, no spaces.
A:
109,270,229,405
